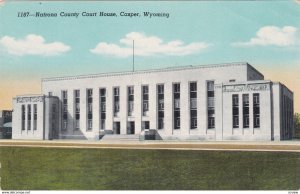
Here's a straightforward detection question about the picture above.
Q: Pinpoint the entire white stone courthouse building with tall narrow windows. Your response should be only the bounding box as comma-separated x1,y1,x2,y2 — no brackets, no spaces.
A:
12,63,294,141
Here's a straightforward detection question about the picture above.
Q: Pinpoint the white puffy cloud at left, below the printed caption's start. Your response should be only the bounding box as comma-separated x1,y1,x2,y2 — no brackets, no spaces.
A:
0,34,70,56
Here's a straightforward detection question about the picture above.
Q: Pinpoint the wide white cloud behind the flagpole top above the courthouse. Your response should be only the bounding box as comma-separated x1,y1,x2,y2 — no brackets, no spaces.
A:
90,32,209,57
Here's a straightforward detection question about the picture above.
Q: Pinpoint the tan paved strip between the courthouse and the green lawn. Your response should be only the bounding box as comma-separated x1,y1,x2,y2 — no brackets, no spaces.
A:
0,140,300,152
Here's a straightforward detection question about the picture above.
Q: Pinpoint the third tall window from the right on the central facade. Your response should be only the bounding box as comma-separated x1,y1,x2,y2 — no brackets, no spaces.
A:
173,83,180,129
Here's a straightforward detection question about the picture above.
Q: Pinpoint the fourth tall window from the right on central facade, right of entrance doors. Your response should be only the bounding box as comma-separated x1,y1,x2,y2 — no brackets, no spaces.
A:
156,84,164,129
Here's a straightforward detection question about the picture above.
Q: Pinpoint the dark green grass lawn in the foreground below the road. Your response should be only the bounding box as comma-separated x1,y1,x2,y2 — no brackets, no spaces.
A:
0,147,300,190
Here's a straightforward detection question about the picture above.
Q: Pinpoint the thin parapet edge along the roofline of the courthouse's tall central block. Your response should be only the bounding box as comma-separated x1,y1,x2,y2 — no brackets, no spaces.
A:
42,62,254,82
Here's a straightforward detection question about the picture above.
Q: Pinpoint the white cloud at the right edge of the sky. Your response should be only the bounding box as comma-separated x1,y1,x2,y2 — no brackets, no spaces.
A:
232,26,299,47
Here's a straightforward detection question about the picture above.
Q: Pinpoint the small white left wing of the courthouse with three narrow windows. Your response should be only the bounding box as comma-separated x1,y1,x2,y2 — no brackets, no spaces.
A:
12,95,59,140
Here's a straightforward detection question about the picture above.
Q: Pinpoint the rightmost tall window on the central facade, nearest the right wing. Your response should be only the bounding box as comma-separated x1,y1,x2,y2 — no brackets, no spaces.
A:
206,81,215,129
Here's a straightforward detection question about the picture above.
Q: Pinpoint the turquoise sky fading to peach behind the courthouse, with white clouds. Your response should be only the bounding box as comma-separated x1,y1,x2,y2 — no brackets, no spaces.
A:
0,0,300,112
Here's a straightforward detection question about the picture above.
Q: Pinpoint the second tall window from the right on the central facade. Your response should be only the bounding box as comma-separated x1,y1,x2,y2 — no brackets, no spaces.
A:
190,82,197,129
